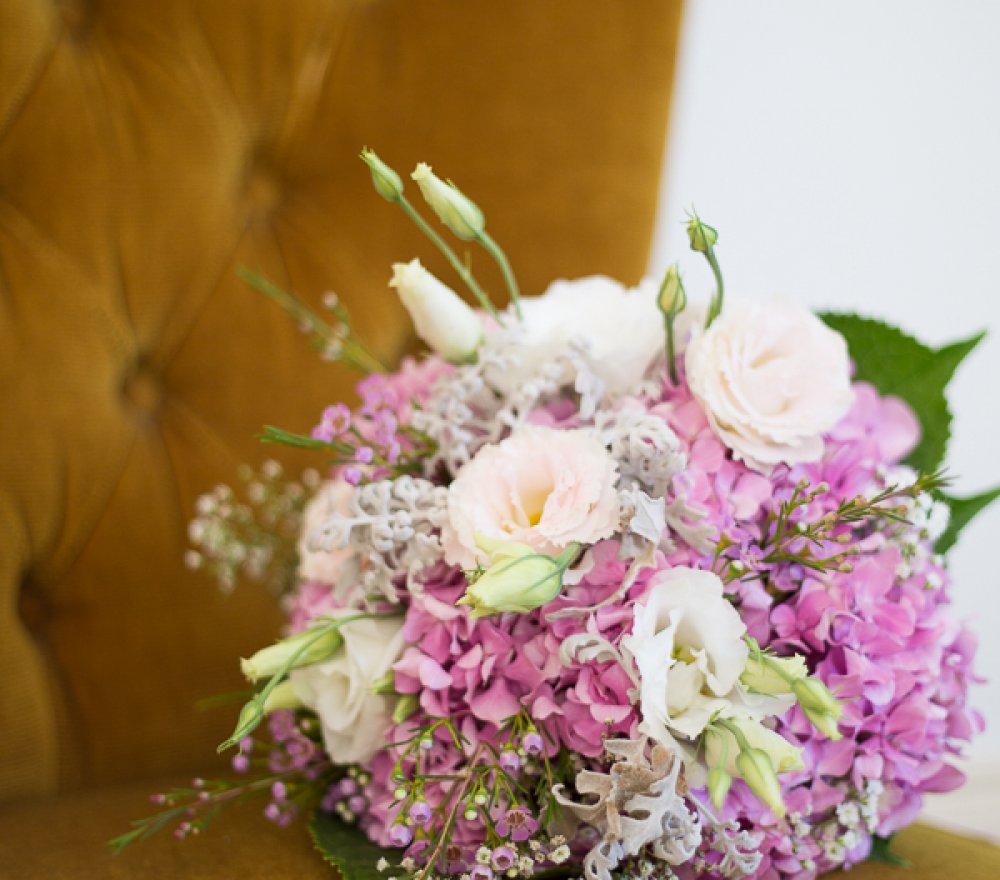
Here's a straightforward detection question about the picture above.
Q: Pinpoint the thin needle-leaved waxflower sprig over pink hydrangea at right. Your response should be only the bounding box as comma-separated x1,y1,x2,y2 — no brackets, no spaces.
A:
712,472,947,583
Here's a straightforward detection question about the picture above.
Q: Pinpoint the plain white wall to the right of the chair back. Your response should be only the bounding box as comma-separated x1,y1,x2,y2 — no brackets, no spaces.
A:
650,0,1000,834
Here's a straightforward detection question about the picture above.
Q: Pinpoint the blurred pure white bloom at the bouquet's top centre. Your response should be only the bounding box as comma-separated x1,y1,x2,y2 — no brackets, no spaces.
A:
498,275,681,394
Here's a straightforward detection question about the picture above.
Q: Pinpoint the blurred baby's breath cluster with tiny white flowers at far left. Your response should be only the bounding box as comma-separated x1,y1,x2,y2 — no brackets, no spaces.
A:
184,461,319,595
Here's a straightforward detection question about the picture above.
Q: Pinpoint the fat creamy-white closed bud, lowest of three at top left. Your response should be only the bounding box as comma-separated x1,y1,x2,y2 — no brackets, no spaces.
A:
389,259,483,363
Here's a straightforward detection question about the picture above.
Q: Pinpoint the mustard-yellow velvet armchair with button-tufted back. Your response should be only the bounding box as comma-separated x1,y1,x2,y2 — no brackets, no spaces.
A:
0,0,992,880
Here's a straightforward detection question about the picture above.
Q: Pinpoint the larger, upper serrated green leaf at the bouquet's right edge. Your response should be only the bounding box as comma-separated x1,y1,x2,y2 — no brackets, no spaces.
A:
820,312,985,473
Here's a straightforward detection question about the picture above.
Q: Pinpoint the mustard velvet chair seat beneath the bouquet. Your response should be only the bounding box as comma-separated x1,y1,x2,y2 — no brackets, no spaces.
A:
0,780,1000,880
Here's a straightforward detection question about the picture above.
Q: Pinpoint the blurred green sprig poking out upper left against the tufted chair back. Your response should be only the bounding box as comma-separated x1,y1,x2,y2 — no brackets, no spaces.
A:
237,266,386,373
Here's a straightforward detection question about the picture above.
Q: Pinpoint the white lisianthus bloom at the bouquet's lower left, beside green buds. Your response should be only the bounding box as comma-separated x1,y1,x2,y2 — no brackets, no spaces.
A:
290,609,403,764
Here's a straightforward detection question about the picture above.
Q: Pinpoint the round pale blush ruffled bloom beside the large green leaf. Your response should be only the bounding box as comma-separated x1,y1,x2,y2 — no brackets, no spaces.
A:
686,301,853,472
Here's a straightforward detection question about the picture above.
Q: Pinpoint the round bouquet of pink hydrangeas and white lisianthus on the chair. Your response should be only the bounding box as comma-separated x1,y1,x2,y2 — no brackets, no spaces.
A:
113,150,988,880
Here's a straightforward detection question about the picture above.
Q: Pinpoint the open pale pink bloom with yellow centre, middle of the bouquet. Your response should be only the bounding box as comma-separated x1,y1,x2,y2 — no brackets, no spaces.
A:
444,426,619,568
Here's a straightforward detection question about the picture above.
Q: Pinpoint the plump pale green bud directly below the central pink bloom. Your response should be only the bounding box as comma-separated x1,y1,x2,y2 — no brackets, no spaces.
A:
458,535,575,617
